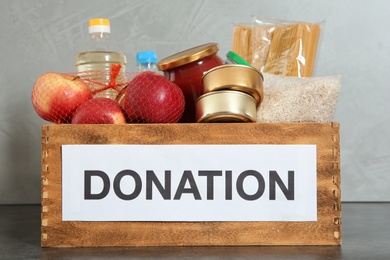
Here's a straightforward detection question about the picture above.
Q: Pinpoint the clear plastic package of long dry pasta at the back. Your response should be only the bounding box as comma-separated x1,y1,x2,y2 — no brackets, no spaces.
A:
232,17,322,77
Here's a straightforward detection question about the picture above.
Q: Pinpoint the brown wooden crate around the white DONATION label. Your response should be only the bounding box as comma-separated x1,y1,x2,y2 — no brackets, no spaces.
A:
41,122,342,247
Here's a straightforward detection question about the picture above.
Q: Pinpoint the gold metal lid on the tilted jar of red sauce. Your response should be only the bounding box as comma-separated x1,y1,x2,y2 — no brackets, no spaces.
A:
157,43,219,70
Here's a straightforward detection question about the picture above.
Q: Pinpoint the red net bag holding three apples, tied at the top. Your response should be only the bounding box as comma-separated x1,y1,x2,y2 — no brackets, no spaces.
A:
31,71,185,124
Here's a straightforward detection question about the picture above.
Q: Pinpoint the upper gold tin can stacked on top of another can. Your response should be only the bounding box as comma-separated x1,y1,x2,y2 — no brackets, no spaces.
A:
202,64,264,106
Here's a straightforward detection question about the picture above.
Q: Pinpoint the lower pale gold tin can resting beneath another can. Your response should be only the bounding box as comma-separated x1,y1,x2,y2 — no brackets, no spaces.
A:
196,90,257,123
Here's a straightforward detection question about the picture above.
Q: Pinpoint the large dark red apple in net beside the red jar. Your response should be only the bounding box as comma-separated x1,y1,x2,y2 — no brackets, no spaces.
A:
123,71,185,123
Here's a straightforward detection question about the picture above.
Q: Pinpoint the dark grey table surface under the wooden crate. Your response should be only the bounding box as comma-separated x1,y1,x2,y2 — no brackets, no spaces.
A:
0,203,390,260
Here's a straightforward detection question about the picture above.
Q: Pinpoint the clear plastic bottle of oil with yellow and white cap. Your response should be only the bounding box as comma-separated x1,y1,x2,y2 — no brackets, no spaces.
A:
76,18,127,99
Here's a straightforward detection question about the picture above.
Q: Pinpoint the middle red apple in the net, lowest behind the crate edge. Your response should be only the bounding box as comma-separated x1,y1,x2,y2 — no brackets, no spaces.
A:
72,98,126,124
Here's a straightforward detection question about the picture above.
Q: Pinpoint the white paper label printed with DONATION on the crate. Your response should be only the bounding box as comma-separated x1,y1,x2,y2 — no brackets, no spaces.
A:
62,144,317,221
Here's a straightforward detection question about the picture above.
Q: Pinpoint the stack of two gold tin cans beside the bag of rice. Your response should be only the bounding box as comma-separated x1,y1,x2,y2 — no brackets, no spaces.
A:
196,64,264,123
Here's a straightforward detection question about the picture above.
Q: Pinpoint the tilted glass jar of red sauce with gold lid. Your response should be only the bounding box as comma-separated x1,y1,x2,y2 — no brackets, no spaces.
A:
157,43,224,123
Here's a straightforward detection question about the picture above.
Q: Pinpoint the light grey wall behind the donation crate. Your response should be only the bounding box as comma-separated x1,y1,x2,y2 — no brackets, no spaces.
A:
0,0,390,204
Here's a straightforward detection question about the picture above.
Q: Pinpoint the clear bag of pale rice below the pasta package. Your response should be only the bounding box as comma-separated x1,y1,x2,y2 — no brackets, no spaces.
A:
257,73,341,122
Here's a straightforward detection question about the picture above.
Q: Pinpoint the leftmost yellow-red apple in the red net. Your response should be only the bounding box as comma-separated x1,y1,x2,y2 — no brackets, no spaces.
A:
31,72,92,123
